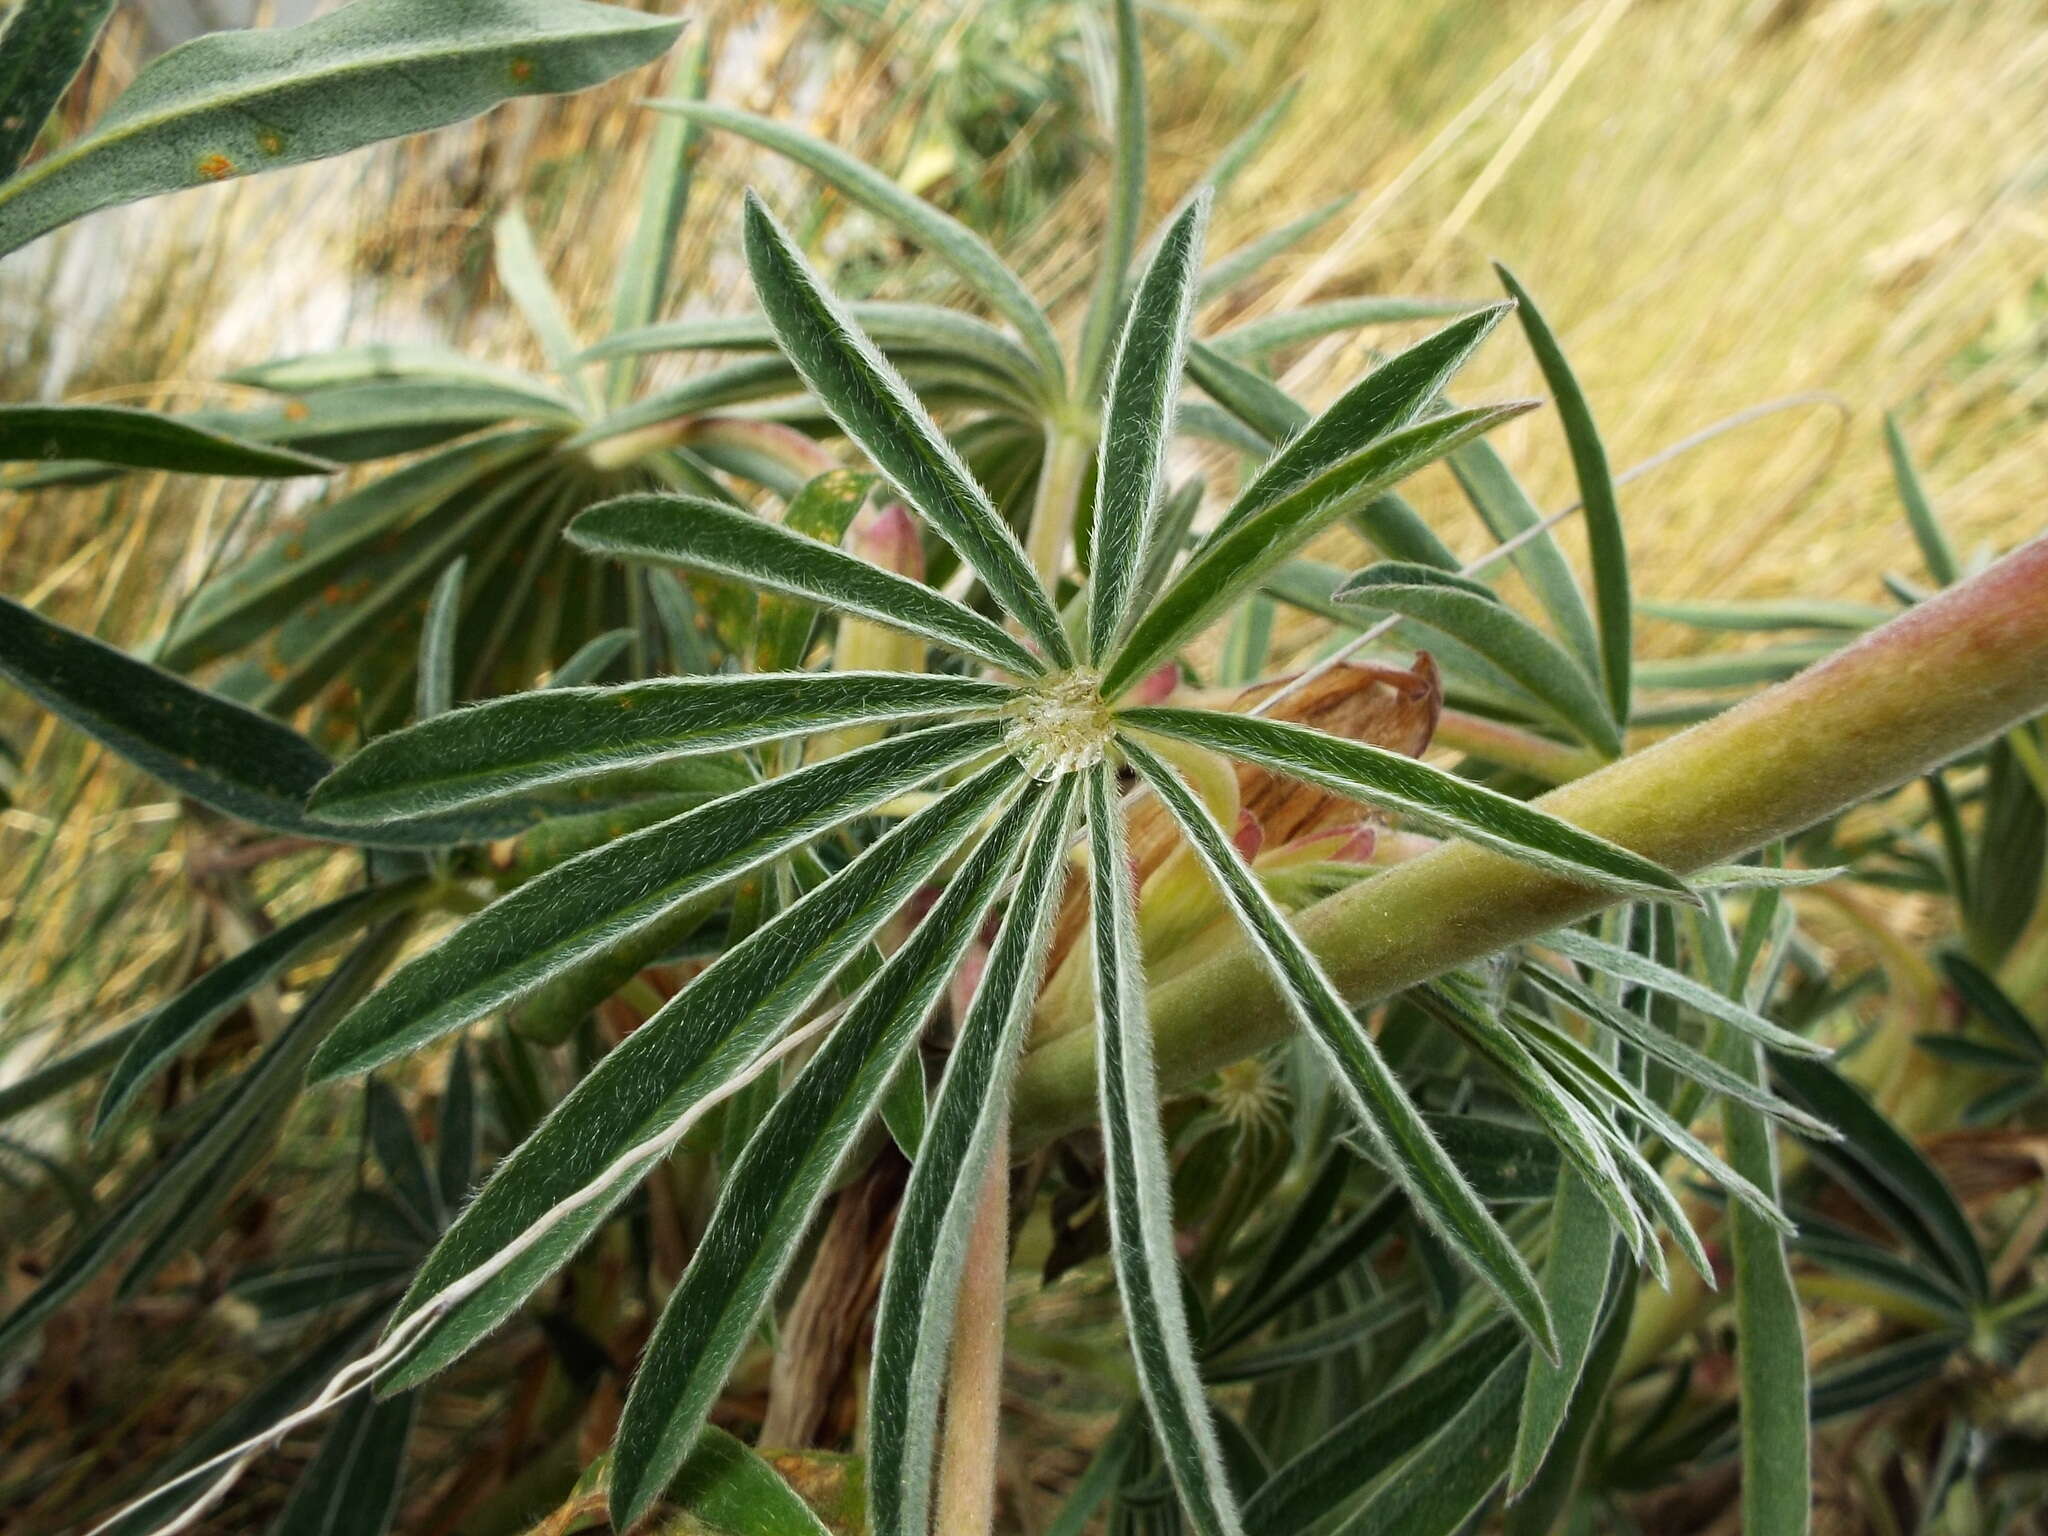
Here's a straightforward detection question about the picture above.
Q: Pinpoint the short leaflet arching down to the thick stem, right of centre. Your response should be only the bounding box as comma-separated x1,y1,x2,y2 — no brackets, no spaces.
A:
1335,561,1622,758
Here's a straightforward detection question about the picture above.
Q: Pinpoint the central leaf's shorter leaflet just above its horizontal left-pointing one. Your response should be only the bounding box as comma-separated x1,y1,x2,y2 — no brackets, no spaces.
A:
569,496,1044,678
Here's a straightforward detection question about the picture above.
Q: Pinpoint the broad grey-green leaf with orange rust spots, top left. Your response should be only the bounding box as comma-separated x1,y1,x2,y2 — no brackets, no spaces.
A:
0,0,682,252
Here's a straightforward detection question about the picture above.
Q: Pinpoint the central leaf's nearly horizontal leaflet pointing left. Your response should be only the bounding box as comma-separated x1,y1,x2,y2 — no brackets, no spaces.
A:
313,672,1016,825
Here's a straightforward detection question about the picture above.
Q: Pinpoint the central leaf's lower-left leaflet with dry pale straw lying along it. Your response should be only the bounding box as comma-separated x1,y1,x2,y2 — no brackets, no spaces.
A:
385,748,1020,1389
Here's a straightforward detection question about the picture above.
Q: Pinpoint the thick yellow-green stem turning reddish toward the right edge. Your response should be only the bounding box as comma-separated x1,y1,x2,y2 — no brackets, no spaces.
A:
1014,539,2048,1153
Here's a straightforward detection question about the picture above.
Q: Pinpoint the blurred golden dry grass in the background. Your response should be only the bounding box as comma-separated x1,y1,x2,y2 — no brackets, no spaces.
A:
0,0,2048,1105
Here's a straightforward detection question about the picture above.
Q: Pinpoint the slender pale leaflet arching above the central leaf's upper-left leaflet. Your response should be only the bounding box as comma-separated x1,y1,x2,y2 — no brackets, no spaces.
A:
651,100,1065,383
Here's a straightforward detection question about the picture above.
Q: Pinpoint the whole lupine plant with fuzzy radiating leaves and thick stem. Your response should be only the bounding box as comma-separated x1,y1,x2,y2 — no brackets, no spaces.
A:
0,6,2048,1536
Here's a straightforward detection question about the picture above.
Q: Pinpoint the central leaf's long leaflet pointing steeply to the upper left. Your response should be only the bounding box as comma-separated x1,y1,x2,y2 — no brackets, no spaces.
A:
745,195,1073,666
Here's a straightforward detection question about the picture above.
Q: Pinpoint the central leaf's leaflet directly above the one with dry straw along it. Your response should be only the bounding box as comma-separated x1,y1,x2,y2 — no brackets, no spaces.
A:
313,723,1004,1079
